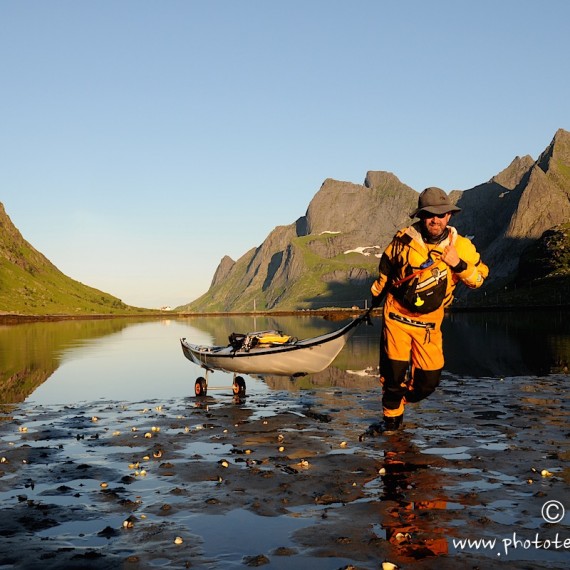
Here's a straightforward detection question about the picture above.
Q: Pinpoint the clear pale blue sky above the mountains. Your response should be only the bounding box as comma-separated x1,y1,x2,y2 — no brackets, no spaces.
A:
0,0,570,307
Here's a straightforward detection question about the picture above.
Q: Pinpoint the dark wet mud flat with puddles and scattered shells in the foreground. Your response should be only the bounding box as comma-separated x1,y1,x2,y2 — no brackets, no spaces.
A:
0,376,570,570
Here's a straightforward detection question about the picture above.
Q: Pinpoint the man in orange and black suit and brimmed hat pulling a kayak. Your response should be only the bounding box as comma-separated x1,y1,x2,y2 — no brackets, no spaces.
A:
370,188,489,432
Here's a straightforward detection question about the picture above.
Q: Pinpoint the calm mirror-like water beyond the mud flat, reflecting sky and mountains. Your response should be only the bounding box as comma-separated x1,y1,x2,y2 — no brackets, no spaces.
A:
0,311,570,404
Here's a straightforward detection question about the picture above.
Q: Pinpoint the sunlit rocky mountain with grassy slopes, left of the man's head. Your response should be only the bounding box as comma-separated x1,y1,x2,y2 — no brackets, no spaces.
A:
186,172,417,311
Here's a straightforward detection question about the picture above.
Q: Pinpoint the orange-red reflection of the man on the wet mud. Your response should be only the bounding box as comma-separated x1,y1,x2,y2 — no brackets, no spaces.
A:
380,431,449,561
